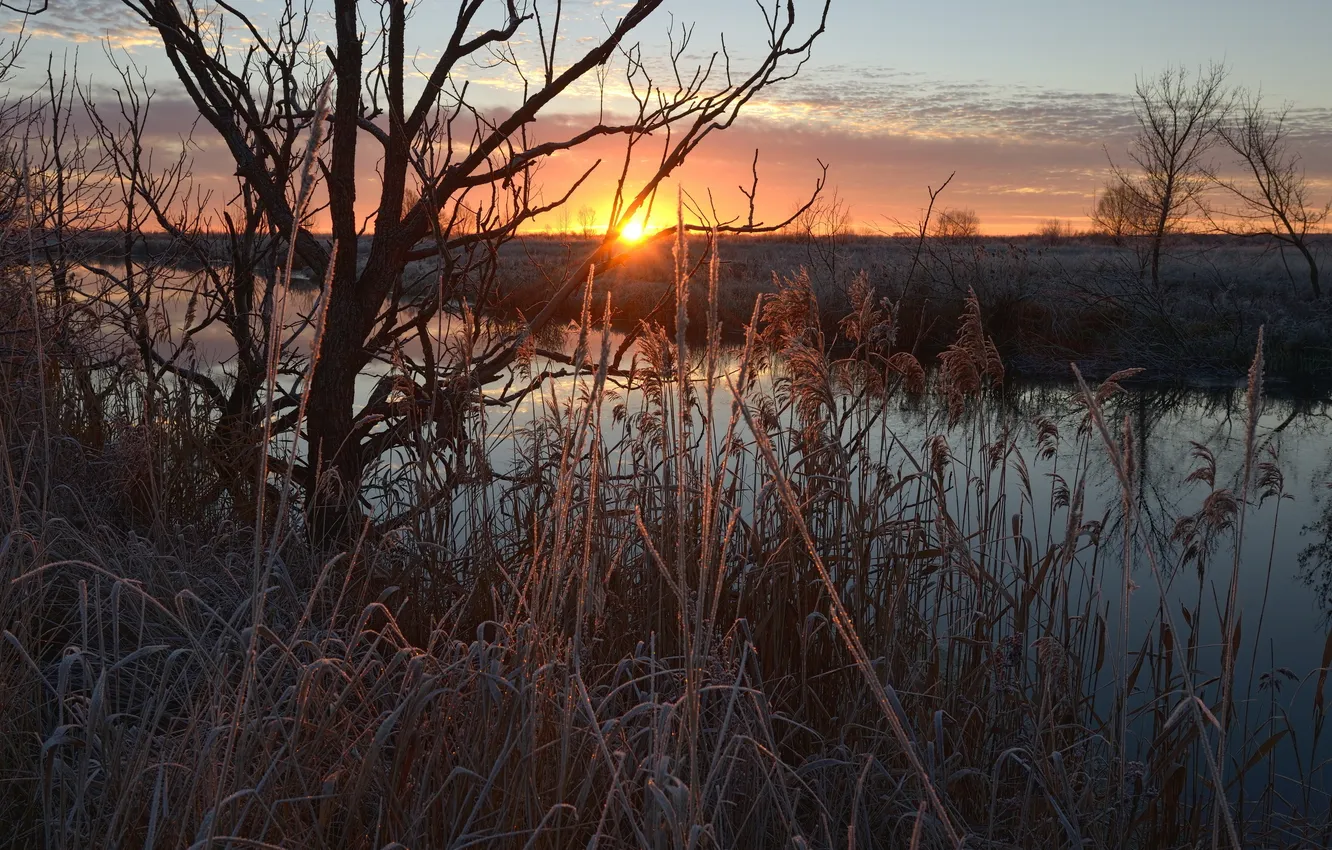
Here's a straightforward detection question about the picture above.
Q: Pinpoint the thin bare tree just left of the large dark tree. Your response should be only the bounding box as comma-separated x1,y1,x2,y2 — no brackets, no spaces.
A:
70,57,327,522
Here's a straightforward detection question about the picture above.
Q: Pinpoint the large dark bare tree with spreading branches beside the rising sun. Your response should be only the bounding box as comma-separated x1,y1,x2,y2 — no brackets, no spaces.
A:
111,0,829,534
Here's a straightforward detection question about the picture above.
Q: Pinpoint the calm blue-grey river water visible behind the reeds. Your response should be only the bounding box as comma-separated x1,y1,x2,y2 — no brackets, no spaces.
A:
88,274,1332,804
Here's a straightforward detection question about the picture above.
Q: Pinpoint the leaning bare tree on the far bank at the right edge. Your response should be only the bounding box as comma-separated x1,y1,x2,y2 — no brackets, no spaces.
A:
1212,95,1332,298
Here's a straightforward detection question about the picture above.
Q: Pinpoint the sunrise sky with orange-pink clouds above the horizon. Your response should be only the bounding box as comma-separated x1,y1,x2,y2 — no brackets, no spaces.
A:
0,0,1332,233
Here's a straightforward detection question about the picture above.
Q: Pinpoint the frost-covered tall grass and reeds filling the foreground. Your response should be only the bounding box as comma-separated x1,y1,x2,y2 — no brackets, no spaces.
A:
0,211,1332,849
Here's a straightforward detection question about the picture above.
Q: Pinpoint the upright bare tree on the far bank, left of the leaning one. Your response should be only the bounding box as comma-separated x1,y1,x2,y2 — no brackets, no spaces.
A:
1111,65,1231,288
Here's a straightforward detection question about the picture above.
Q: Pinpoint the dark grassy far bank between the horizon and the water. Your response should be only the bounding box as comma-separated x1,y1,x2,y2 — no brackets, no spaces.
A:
484,236,1332,385
